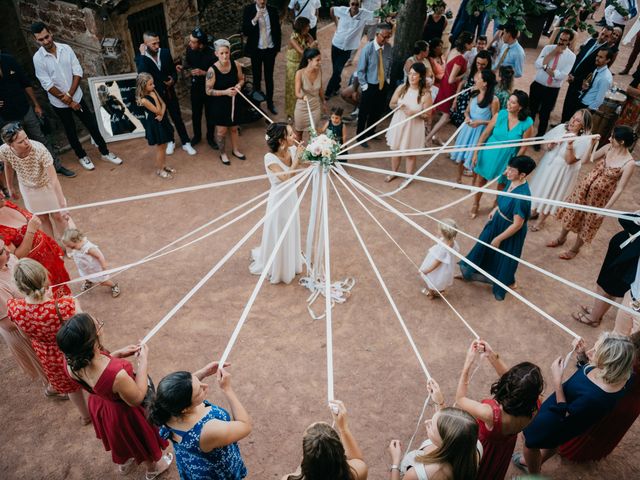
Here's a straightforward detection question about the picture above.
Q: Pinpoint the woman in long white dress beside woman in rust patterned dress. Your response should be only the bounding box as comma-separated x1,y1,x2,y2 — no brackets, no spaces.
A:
529,108,593,232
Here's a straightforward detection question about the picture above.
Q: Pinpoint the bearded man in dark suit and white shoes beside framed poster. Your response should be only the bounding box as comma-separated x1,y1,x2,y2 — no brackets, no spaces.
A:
136,32,196,155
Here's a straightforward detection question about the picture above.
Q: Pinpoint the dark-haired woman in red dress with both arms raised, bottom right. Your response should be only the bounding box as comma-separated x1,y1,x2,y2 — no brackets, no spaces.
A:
456,340,543,480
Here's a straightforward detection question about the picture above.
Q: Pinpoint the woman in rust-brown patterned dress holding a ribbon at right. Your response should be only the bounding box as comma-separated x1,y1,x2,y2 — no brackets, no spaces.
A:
547,126,635,260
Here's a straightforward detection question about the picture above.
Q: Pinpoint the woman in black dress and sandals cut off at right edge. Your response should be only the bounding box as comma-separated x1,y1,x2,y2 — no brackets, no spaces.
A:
571,213,640,328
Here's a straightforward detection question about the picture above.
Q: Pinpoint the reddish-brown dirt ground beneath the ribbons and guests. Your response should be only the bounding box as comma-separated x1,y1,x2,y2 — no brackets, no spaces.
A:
0,2,640,480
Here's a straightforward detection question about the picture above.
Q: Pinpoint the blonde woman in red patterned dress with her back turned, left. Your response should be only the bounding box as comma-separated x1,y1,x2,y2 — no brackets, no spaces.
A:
7,258,91,425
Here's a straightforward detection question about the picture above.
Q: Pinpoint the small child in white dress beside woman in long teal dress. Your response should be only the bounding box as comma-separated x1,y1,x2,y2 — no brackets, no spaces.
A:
420,218,460,298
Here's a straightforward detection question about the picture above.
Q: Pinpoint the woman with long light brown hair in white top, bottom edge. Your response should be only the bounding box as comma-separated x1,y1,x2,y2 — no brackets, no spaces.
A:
388,404,482,480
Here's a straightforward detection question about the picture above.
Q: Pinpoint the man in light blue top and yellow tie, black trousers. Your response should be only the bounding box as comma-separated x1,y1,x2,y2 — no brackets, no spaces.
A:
357,23,393,144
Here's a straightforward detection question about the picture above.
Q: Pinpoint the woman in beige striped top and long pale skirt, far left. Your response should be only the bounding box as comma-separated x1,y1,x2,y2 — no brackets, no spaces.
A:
0,123,69,237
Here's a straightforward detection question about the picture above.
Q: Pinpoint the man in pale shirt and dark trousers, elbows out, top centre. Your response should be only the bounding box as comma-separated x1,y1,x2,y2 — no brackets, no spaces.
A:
324,0,373,98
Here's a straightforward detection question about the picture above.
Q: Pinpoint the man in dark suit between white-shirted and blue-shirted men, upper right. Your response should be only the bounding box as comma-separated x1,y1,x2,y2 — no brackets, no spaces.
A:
562,26,613,122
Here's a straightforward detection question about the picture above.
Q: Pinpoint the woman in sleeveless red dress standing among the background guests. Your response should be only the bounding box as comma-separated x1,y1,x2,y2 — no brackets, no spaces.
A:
427,32,473,143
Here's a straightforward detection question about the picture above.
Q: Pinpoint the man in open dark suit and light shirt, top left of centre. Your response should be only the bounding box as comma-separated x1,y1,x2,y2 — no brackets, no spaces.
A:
242,0,282,115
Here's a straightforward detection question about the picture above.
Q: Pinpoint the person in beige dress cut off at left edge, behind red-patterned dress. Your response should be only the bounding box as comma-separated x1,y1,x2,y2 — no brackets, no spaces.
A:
0,255,45,382
